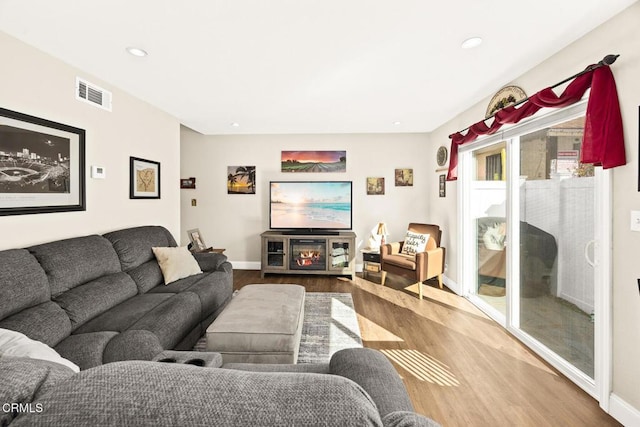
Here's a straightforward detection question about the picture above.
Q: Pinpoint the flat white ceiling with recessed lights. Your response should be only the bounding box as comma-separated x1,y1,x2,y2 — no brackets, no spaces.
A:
0,0,635,134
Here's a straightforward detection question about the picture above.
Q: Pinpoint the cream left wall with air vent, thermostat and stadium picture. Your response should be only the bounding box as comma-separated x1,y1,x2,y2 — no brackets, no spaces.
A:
0,32,180,249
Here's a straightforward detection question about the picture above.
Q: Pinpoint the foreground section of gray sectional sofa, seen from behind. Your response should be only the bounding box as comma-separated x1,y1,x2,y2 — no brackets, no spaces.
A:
0,348,437,427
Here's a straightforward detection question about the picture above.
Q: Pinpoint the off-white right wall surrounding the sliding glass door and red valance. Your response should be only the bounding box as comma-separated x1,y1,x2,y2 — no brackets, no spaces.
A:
427,3,640,425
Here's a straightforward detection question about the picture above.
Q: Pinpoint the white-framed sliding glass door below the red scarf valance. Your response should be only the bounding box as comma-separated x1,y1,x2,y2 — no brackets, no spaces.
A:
459,104,611,399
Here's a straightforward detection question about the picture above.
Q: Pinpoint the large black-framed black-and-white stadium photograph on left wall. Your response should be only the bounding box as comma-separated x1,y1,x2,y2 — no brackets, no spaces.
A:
0,108,86,215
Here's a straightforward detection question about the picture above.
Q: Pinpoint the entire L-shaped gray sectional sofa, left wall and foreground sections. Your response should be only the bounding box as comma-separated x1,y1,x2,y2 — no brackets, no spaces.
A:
0,226,437,427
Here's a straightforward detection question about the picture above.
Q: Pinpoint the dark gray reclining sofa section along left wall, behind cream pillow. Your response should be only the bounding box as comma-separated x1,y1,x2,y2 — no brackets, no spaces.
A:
0,226,233,370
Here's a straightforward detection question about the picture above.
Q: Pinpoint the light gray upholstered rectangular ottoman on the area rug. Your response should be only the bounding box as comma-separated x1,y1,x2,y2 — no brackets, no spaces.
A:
207,285,305,363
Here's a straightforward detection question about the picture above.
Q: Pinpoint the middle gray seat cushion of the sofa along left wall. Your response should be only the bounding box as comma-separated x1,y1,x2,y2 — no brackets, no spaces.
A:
74,294,173,334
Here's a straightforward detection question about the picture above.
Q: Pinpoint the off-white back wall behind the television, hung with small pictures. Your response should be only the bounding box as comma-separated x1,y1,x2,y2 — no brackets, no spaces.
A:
181,127,430,268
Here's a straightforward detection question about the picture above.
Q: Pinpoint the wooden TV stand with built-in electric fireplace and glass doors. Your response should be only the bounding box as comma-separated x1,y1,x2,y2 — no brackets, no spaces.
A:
260,231,356,280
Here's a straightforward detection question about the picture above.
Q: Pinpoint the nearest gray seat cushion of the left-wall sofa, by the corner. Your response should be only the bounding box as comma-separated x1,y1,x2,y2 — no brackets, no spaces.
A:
55,331,118,370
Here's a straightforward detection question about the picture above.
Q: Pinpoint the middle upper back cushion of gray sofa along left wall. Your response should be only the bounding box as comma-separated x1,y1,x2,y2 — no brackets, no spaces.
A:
28,235,121,297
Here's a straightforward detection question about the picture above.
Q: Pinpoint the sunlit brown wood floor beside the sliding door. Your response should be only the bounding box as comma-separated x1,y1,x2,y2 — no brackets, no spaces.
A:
234,270,621,427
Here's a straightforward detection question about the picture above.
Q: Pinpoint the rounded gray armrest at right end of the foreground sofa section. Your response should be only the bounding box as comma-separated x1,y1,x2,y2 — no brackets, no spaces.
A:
329,348,413,418
